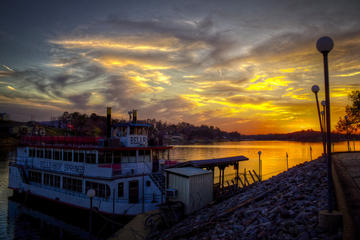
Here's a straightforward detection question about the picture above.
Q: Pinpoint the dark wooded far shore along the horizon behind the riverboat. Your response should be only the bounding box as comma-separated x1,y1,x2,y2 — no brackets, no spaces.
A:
0,112,359,144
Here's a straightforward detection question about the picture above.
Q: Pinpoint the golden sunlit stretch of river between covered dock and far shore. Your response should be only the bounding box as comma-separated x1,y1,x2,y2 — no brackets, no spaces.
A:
170,141,360,183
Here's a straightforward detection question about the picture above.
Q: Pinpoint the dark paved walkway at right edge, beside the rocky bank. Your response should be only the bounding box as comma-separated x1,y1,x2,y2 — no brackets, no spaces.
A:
332,152,360,239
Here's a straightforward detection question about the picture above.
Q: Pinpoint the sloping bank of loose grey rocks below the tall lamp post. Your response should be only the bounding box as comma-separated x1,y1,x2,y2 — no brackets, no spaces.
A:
153,158,342,240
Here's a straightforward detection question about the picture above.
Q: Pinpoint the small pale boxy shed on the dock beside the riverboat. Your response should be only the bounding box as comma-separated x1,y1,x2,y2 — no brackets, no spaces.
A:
165,167,214,214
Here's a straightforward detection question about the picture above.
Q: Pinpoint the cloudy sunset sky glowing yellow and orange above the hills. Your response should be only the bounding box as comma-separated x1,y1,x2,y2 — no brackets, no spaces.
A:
0,0,360,134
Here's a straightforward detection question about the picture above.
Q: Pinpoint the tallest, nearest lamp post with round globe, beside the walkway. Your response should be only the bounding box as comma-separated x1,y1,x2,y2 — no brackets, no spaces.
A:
316,37,334,213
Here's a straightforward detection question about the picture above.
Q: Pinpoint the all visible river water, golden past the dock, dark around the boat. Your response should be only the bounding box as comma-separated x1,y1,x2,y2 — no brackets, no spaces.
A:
0,141,360,239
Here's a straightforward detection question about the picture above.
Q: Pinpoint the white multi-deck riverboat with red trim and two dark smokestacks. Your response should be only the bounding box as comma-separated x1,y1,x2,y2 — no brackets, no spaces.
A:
9,108,171,215
